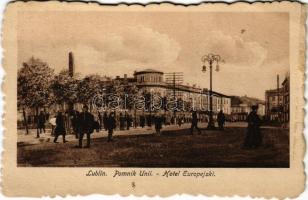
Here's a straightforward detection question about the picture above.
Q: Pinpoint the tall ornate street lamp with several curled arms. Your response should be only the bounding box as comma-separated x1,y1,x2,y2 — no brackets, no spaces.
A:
201,53,223,129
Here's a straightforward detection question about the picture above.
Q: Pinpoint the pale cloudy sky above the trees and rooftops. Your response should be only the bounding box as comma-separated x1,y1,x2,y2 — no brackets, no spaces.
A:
18,11,289,99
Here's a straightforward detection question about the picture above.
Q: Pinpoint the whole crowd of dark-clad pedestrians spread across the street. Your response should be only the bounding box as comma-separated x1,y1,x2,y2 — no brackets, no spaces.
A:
24,105,262,149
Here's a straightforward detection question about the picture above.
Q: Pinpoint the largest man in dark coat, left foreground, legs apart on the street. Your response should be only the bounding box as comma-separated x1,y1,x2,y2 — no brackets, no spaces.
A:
78,105,94,148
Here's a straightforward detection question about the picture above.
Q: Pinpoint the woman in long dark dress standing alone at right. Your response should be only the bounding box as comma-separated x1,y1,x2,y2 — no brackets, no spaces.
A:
244,105,262,149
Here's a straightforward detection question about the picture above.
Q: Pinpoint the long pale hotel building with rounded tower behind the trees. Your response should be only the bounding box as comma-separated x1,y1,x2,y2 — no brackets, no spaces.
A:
114,69,231,115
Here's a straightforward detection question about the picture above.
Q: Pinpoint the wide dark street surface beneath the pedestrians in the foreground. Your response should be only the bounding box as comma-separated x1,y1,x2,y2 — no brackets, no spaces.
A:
18,123,289,167
